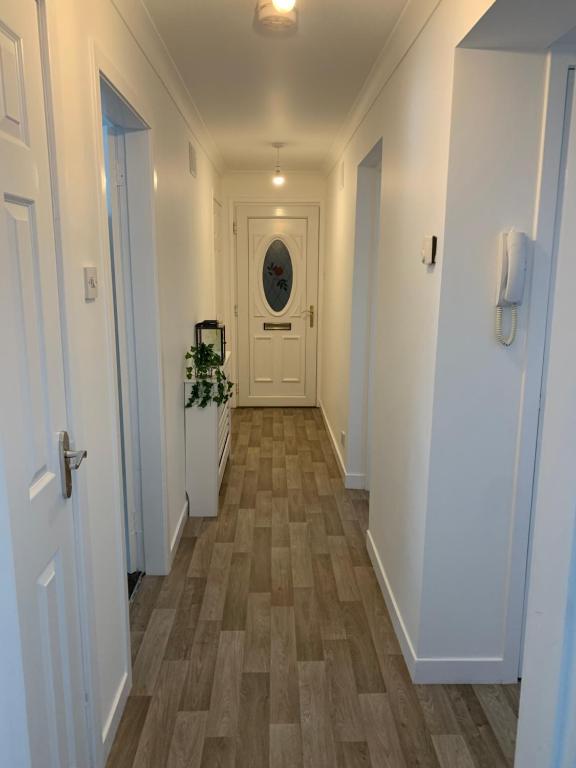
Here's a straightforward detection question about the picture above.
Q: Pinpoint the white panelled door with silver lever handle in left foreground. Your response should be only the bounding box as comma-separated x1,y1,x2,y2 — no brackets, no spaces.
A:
0,0,89,768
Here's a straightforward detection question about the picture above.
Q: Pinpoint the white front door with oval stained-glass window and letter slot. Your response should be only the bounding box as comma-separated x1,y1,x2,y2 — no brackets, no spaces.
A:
237,205,319,406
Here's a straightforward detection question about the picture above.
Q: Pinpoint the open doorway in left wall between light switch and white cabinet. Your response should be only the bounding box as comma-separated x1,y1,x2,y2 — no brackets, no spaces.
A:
100,79,147,597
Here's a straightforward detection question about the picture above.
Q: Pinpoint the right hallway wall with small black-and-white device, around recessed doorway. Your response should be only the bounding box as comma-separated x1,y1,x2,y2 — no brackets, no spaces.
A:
321,0,500,660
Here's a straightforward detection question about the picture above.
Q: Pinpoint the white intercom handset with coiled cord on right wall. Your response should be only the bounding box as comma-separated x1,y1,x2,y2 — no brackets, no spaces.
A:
496,229,528,347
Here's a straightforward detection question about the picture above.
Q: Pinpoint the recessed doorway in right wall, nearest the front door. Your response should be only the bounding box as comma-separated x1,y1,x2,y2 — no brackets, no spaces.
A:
346,140,382,490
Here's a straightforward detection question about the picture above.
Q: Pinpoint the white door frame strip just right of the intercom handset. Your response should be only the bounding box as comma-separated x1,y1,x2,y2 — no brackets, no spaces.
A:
476,52,573,680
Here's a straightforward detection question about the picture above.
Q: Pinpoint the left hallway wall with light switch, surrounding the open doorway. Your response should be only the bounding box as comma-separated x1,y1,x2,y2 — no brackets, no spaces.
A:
43,0,219,756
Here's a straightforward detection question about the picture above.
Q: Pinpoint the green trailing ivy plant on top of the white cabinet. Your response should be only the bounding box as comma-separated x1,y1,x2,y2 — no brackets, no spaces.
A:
185,343,234,408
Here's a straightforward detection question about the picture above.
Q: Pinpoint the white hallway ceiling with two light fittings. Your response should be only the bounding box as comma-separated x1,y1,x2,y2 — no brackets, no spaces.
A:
144,0,406,170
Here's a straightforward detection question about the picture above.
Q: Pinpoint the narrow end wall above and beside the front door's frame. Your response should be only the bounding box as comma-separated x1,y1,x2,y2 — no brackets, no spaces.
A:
221,172,326,405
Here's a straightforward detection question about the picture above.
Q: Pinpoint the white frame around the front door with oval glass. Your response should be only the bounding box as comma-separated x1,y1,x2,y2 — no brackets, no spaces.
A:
231,200,323,407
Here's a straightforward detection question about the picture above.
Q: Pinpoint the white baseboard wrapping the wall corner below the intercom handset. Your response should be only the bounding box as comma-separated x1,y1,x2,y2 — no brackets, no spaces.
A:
366,531,508,684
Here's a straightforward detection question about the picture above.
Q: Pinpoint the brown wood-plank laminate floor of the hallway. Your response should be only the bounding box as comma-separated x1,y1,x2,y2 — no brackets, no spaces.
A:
108,408,519,768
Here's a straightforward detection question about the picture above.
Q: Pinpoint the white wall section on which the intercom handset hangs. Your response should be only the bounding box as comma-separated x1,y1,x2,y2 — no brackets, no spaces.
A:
417,50,546,679
